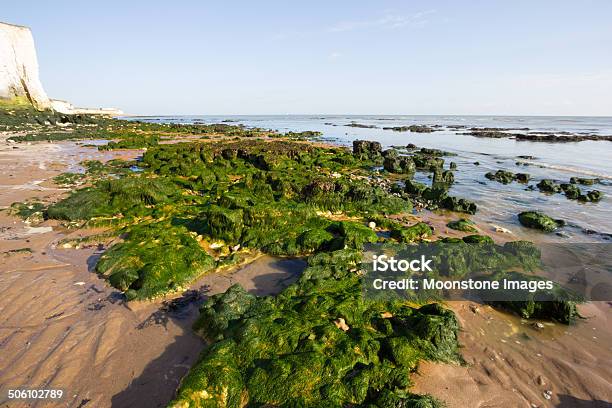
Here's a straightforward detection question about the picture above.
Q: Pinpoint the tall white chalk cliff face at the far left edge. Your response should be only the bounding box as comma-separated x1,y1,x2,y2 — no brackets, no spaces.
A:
0,23,51,109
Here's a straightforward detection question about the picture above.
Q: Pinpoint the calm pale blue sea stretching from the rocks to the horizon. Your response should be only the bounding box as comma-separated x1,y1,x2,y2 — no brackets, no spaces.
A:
130,115,612,242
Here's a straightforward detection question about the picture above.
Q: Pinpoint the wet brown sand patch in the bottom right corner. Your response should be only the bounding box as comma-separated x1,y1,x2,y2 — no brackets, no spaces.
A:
413,302,612,408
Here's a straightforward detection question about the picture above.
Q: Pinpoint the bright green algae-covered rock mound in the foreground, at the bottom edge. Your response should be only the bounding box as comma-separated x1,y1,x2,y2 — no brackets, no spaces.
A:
171,250,460,407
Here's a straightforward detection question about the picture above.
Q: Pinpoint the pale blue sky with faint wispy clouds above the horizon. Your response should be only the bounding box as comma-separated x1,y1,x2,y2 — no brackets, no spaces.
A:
0,0,612,116
